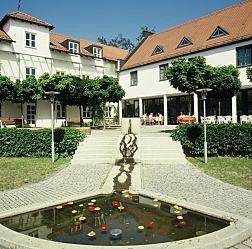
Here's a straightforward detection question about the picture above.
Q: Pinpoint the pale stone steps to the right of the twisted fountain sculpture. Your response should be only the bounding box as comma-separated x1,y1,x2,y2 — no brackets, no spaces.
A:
139,129,186,164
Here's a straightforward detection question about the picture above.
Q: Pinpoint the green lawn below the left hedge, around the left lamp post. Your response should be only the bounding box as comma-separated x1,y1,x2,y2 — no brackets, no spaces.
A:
0,157,70,191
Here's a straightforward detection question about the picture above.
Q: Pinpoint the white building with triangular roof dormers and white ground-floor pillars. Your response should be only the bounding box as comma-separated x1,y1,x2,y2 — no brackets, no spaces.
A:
119,0,252,124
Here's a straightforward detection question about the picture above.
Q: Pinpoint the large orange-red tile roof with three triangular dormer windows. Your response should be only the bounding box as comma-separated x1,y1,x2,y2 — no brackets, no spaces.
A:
122,0,252,70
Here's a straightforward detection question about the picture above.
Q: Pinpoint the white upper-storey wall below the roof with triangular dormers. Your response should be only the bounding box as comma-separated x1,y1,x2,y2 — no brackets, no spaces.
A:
119,40,252,99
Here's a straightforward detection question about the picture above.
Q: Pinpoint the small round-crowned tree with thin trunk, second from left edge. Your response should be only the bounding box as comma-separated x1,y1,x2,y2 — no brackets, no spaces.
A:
11,76,43,127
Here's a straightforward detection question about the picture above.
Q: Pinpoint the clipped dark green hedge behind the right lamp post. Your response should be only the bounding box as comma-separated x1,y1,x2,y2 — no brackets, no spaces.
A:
171,124,252,157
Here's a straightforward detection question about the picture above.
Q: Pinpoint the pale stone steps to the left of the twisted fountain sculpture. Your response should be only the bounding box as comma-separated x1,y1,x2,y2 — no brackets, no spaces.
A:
71,130,120,164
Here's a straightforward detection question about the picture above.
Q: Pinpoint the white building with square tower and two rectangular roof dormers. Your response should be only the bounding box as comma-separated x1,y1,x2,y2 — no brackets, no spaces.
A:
0,12,127,127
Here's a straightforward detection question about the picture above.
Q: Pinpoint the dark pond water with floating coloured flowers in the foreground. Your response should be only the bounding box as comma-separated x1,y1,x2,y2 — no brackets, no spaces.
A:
0,194,228,246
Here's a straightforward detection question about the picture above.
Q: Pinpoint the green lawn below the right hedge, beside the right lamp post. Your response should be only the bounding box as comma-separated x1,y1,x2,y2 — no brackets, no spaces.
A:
187,157,252,190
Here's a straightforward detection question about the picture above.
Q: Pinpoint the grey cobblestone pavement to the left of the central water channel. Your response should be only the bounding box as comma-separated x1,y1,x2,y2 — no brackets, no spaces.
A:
0,164,111,212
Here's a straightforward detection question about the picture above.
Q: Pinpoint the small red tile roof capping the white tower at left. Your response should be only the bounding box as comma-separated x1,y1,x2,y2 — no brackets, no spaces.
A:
0,11,54,30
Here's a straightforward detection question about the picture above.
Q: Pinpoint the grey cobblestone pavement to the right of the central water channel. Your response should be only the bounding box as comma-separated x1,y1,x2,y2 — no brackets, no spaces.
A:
143,163,252,249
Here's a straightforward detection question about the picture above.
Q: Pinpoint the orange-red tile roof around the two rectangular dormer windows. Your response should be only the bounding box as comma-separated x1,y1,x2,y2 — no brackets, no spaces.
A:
50,33,128,61
